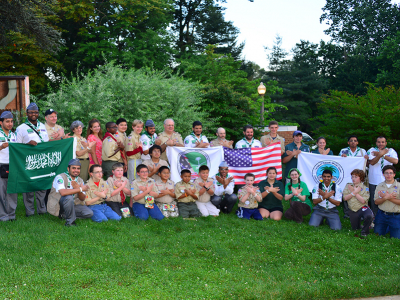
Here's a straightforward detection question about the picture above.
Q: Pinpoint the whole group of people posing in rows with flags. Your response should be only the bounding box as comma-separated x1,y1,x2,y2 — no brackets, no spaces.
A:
0,103,400,238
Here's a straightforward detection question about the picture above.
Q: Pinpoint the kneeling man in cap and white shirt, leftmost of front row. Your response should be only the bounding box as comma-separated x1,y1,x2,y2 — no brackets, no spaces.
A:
47,158,93,226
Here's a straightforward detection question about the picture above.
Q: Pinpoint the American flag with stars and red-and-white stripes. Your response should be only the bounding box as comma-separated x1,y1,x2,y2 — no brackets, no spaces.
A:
224,142,282,184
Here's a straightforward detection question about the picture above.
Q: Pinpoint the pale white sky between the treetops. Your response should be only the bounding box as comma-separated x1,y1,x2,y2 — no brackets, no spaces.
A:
222,0,330,69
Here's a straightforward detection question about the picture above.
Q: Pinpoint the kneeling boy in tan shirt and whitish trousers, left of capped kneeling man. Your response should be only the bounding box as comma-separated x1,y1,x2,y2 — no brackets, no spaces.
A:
194,165,219,217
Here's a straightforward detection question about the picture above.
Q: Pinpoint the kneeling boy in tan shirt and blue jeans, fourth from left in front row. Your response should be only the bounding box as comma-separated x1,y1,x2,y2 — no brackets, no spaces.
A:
130,164,164,221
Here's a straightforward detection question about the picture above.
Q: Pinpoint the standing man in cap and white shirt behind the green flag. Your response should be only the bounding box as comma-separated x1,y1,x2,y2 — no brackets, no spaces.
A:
16,102,49,217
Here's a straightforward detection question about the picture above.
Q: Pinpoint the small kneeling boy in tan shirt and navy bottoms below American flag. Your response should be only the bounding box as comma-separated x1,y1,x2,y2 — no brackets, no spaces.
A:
236,173,263,221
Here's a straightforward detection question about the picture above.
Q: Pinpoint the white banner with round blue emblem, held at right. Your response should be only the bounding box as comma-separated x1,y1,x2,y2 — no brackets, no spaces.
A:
297,152,366,191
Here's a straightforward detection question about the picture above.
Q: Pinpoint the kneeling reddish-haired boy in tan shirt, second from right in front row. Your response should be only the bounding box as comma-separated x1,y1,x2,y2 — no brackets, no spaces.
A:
343,169,374,237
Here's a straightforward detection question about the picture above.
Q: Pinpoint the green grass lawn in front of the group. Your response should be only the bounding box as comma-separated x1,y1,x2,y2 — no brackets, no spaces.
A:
0,199,400,299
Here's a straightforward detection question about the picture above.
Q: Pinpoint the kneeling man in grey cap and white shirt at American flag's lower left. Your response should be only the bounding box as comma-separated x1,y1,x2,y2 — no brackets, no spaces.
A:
211,161,238,214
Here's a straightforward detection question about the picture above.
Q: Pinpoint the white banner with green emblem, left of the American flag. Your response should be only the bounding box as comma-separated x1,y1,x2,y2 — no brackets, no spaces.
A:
167,146,224,183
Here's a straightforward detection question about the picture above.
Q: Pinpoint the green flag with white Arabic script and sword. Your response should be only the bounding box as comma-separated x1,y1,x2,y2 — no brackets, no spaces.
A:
7,139,75,193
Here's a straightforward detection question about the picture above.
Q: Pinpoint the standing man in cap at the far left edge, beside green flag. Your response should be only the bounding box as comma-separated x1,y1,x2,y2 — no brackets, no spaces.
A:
0,111,18,221
